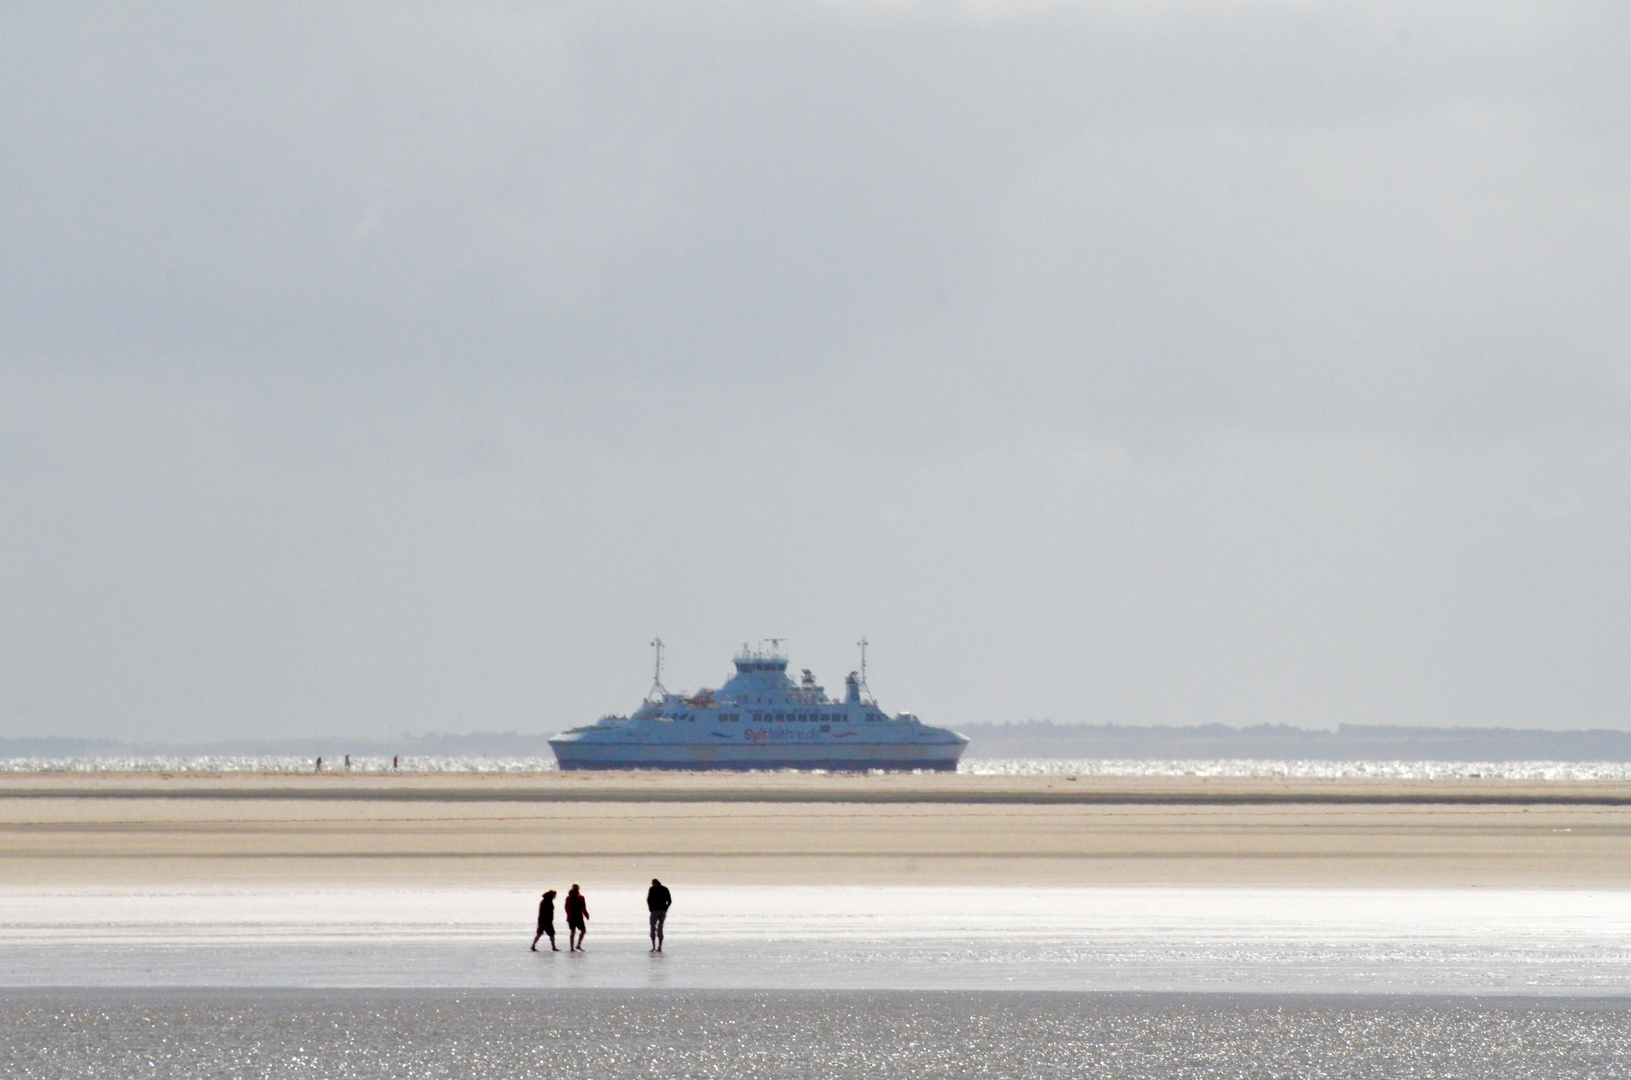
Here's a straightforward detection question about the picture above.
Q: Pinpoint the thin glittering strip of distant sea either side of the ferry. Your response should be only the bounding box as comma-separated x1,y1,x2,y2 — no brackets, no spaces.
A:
9,754,1631,781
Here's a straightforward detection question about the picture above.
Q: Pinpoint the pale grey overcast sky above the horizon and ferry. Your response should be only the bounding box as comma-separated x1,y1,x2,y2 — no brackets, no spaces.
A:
0,0,1631,739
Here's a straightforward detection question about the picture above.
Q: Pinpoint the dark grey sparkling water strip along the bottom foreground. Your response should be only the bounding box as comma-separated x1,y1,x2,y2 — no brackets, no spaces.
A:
0,990,1631,1080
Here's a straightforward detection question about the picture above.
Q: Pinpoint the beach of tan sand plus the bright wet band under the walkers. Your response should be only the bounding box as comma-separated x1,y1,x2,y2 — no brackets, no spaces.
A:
0,772,1631,998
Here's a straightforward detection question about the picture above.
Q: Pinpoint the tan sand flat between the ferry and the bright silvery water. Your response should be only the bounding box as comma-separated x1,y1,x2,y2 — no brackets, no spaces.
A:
0,773,1631,889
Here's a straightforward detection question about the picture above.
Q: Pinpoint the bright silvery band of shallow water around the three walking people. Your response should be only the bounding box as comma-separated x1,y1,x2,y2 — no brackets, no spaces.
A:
0,883,1631,995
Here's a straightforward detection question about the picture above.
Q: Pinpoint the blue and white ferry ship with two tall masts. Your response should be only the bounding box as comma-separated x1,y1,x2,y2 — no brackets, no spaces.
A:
550,640,969,772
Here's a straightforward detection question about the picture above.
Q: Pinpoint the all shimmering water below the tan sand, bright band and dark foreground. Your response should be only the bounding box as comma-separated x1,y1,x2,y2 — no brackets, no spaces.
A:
0,887,1631,1080
